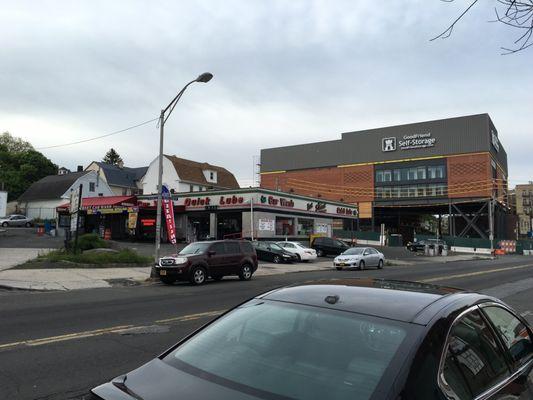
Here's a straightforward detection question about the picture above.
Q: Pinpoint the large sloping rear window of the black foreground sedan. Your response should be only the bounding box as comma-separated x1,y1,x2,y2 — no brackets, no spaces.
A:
164,300,415,400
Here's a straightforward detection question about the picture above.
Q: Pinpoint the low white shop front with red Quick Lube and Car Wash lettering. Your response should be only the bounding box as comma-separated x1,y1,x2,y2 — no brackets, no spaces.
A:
138,188,358,242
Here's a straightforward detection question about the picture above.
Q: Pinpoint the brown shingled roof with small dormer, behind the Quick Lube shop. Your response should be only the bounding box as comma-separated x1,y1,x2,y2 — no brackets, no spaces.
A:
165,155,239,189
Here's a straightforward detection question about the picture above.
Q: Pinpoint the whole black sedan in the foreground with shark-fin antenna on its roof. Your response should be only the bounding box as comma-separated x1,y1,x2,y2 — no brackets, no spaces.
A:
92,279,533,400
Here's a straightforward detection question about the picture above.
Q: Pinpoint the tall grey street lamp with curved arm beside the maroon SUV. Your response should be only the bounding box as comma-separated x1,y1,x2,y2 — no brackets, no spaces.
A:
155,72,213,265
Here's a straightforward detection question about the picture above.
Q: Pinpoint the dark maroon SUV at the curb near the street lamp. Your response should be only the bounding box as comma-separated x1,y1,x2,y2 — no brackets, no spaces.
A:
156,240,257,285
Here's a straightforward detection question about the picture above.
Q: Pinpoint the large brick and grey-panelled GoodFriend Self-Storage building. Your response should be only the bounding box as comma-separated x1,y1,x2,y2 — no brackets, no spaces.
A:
261,114,509,242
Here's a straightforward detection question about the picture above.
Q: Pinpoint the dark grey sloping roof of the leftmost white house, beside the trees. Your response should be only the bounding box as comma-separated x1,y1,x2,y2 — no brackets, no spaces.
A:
18,171,91,201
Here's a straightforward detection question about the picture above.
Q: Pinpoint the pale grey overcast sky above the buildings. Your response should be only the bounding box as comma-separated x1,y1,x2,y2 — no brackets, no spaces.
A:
0,0,533,185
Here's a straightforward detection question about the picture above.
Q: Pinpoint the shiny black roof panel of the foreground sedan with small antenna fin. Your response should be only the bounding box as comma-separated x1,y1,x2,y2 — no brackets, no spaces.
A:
259,278,471,325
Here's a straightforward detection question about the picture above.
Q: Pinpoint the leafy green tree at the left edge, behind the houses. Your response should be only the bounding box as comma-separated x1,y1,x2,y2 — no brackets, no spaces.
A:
0,132,57,201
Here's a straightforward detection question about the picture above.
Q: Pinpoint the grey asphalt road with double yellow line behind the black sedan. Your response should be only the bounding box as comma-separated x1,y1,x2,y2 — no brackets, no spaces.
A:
0,257,533,400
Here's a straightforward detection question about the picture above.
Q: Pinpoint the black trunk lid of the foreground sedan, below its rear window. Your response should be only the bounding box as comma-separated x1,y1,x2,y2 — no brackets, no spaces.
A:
92,358,264,400
